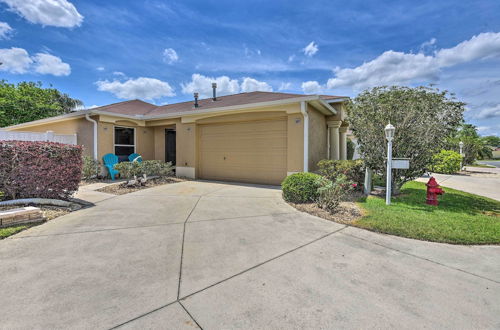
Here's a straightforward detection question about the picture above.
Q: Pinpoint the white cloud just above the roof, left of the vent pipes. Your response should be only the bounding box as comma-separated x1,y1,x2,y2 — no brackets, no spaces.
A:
96,77,175,100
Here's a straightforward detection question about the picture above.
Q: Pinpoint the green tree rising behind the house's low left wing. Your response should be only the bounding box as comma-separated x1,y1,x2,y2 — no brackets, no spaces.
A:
0,80,83,127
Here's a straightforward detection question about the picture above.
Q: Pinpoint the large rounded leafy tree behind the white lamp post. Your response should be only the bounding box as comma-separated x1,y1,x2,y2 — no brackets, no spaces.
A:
347,86,465,192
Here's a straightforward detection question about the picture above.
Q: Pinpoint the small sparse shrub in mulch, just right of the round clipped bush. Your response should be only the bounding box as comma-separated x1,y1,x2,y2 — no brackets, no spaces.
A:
317,174,354,212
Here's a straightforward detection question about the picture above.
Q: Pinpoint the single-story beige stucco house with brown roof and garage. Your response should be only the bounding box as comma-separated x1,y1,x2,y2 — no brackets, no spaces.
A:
4,91,347,184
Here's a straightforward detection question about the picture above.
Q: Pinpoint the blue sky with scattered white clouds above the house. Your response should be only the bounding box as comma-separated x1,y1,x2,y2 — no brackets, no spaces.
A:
0,0,500,135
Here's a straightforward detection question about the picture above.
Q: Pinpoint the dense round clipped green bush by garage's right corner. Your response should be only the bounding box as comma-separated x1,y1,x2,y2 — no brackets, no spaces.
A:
281,173,321,203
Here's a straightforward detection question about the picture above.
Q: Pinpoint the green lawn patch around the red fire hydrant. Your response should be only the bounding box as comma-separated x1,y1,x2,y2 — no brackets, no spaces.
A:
354,182,500,244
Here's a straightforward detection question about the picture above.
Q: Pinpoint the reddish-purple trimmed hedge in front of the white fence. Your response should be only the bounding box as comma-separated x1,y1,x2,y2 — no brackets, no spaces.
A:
0,141,82,199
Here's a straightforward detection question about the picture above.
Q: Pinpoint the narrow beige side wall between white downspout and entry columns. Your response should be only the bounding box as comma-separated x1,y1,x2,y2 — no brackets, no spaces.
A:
307,106,328,172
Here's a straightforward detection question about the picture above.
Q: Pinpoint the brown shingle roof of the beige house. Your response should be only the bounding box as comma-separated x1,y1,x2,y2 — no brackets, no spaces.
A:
92,92,343,116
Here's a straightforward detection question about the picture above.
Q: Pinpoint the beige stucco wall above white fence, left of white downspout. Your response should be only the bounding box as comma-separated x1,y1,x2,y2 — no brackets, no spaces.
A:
11,118,94,156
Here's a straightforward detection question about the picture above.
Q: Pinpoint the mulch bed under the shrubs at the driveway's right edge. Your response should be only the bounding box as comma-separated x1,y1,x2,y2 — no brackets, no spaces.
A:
288,192,363,224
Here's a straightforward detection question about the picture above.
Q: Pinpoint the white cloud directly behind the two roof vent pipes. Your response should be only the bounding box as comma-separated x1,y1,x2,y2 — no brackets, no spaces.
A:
181,73,240,98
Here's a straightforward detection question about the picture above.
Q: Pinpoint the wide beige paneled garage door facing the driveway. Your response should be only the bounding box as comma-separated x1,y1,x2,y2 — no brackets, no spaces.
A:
199,118,287,184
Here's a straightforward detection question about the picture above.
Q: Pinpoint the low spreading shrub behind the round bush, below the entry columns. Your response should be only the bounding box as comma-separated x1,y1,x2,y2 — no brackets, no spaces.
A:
318,159,365,189
